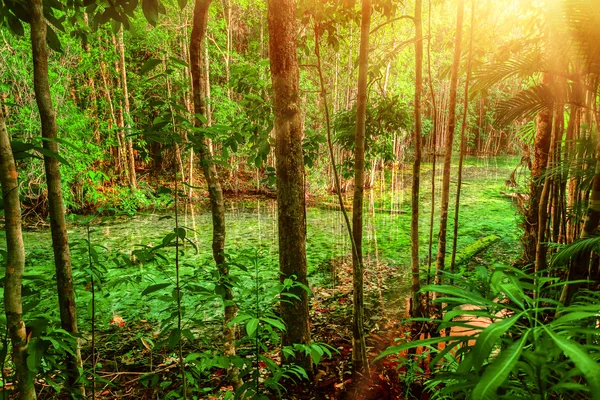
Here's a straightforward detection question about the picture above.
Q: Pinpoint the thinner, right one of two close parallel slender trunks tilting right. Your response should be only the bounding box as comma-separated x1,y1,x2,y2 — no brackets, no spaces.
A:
450,0,475,273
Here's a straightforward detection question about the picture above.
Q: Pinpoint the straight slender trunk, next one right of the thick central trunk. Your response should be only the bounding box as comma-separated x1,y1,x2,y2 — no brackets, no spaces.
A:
352,0,371,375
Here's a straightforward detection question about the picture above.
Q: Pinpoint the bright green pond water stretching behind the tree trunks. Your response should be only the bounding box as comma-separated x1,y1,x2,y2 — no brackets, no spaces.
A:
2,158,519,329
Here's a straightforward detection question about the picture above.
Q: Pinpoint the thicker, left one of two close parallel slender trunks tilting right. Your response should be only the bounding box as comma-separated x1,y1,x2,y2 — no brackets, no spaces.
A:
435,0,465,284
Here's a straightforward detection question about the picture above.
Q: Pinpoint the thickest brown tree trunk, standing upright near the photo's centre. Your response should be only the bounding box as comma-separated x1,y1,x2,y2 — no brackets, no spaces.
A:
268,0,312,375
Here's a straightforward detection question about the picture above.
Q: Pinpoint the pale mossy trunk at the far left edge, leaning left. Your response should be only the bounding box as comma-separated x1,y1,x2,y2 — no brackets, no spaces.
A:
0,109,36,400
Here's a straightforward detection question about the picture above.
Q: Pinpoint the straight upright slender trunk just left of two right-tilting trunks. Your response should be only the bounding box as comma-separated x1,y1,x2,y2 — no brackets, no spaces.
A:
410,0,423,317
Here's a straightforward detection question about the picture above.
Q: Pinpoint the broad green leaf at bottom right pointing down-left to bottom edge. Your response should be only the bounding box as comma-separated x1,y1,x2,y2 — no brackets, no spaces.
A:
471,331,529,400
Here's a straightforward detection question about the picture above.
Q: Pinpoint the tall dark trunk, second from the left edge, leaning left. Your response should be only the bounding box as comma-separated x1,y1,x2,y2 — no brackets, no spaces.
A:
30,0,83,390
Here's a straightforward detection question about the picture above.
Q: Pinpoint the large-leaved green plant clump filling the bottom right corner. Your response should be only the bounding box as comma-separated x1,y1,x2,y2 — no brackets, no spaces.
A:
379,266,600,399
